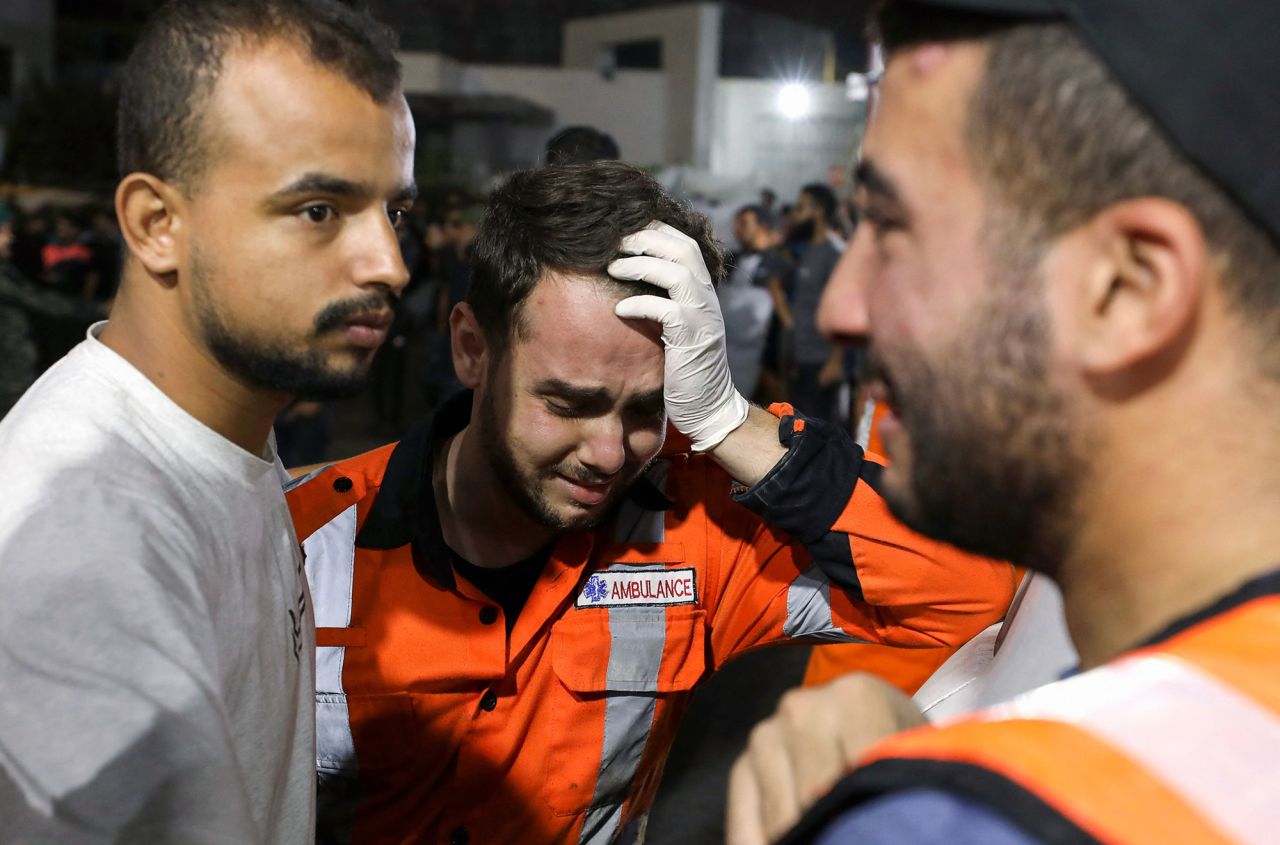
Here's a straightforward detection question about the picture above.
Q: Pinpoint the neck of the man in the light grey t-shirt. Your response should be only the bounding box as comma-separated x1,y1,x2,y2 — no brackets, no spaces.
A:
99,286,291,455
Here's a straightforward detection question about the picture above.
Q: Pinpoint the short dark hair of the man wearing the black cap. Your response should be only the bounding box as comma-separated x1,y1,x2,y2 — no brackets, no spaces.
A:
878,0,1280,379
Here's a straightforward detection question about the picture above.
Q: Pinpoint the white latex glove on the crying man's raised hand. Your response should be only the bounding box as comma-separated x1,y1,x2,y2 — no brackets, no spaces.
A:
609,221,750,452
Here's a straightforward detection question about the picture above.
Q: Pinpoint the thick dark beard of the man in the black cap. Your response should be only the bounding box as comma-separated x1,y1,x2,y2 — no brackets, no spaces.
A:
872,229,1087,575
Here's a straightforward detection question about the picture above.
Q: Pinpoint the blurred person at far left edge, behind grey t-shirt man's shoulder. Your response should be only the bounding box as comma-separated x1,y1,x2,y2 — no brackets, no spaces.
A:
0,206,102,417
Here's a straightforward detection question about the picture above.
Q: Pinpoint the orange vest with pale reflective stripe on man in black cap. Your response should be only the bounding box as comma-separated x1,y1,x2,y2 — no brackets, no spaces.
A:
783,571,1280,845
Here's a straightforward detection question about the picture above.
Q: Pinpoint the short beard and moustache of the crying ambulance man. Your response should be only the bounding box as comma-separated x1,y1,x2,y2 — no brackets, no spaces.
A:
476,365,646,531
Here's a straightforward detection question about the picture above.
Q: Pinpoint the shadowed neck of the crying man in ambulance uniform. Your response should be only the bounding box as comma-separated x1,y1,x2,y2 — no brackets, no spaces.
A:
433,424,556,568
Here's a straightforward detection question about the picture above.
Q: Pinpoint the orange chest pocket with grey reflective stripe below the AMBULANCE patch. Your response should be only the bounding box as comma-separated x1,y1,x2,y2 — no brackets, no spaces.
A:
544,606,707,822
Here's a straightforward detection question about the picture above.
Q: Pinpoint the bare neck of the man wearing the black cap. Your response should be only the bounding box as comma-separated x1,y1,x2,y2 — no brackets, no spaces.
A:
1057,379,1280,668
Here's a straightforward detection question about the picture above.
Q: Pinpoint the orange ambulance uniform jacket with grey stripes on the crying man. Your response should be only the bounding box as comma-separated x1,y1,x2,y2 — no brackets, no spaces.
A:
288,401,1014,845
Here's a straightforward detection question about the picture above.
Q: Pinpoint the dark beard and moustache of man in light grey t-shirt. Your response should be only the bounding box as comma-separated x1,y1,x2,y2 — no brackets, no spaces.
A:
191,250,396,399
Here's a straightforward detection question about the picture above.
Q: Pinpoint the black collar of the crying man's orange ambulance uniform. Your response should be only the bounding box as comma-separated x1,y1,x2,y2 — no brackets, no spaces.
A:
356,390,672,589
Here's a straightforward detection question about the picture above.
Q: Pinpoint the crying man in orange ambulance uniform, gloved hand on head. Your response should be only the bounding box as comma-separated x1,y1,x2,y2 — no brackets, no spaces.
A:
288,161,1014,844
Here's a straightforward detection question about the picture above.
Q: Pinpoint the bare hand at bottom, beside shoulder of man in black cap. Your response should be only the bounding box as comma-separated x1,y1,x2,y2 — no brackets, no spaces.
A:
726,673,928,845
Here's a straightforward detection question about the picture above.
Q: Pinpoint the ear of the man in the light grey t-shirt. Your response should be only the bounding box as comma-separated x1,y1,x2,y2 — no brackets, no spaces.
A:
115,173,187,279
